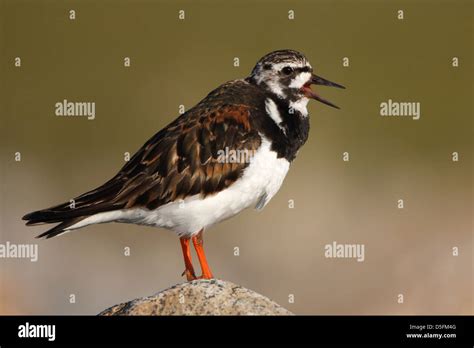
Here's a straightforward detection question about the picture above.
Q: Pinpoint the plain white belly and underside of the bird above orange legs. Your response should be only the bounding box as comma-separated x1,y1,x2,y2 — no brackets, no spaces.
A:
66,137,290,236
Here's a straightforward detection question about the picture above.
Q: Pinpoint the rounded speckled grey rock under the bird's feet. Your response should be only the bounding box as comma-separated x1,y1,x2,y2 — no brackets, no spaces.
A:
99,279,292,315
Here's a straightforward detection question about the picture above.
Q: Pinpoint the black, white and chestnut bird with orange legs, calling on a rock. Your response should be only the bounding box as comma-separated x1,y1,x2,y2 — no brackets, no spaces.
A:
23,49,345,281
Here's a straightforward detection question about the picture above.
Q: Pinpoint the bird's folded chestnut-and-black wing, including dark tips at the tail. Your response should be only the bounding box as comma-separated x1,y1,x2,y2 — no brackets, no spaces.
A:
23,102,261,226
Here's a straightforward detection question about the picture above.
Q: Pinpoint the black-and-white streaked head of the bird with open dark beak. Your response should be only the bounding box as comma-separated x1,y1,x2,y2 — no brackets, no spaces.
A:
248,50,345,108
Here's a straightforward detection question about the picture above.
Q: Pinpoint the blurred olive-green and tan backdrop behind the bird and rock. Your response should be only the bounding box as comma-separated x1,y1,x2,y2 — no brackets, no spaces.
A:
0,0,474,314
